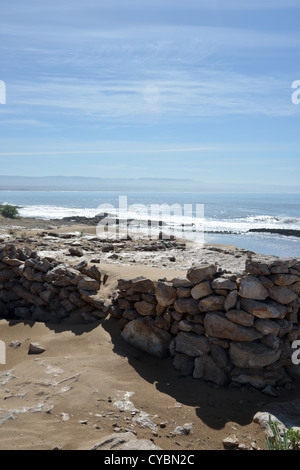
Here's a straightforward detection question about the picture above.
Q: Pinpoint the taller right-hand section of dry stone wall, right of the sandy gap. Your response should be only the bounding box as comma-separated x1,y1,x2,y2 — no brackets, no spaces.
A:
114,258,300,388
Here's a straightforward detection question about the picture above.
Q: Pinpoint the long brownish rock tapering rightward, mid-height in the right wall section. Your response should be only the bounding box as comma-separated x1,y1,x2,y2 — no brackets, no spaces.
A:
204,312,262,341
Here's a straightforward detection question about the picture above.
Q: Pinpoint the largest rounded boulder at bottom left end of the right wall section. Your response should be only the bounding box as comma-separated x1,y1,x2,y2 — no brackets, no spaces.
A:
121,317,172,357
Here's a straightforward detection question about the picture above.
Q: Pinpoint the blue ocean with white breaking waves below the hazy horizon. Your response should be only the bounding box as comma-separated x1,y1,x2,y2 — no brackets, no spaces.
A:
0,191,300,257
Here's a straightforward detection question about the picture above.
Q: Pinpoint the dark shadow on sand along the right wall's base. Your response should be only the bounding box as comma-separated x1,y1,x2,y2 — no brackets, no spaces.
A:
102,318,300,430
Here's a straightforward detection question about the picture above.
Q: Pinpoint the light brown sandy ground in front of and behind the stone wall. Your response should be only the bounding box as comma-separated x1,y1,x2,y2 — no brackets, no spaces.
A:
0,218,300,451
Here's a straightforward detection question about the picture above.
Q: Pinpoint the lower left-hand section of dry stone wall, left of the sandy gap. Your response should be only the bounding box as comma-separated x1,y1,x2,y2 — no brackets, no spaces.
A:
0,243,110,322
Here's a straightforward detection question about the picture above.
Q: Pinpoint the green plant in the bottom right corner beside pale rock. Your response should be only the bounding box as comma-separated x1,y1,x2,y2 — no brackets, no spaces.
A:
265,416,300,450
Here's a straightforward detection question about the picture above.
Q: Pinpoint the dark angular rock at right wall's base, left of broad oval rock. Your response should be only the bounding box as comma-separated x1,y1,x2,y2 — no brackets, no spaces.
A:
193,354,228,385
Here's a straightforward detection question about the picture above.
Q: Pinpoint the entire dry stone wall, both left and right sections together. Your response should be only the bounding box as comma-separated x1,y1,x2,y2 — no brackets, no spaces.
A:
0,243,300,388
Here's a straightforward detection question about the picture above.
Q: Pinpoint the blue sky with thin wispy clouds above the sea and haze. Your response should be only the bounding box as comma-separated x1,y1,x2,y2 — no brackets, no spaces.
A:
0,0,300,191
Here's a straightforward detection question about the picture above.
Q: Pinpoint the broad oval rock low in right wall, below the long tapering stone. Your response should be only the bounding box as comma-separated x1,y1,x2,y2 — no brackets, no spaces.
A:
229,341,281,369
